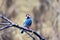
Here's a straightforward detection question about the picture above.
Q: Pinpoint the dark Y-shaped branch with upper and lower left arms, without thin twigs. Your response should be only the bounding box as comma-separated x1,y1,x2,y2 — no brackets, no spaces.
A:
0,15,45,40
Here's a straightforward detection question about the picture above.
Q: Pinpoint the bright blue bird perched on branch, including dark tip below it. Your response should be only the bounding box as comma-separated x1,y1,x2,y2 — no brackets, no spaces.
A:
21,14,32,33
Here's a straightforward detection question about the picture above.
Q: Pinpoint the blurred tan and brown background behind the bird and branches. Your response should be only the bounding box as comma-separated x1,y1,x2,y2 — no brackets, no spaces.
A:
0,0,60,40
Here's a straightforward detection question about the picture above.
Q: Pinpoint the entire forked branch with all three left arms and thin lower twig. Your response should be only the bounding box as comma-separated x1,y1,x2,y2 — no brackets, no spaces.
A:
0,14,45,40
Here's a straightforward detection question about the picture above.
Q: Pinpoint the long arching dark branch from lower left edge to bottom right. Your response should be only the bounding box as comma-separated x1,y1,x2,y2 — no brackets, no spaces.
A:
0,25,45,40
